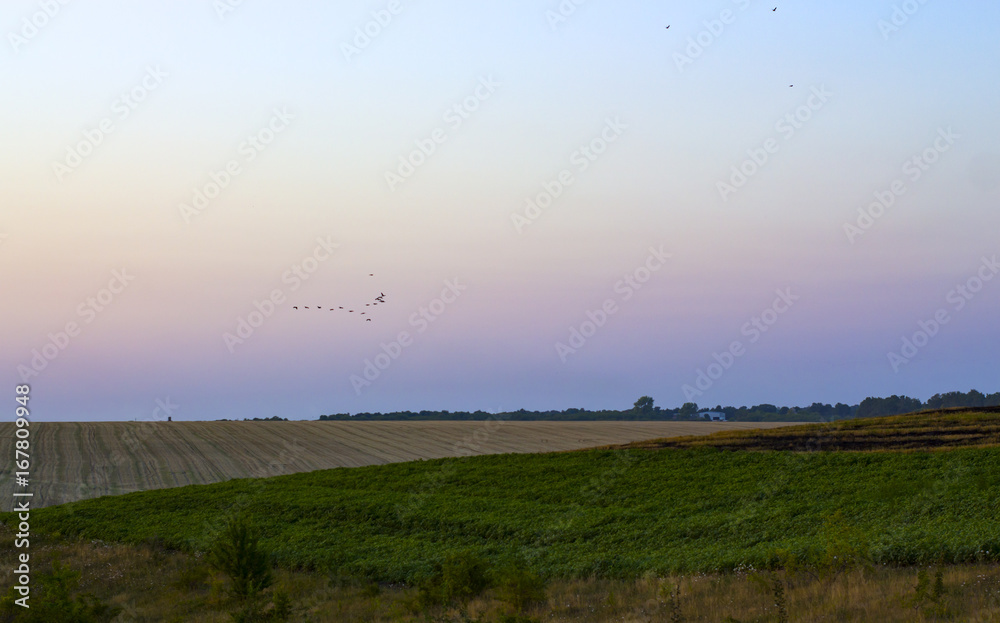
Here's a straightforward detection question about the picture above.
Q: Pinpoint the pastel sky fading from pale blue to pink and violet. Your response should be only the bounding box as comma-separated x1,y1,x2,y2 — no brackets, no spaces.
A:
0,0,1000,421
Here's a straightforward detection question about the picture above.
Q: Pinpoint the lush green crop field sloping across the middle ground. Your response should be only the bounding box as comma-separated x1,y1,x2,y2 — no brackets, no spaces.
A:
13,415,1000,581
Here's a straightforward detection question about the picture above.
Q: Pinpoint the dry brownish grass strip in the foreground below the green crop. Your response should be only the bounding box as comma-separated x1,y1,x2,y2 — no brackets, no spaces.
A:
0,530,1000,623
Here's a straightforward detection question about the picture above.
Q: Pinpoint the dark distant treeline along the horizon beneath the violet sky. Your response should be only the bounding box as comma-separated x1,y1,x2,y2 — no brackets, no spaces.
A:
319,389,1000,422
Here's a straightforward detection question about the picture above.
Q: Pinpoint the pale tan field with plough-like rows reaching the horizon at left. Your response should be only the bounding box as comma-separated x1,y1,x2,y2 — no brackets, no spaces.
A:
0,420,789,508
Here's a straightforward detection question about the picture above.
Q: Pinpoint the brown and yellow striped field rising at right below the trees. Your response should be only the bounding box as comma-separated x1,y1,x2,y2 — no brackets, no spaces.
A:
608,407,1000,452
